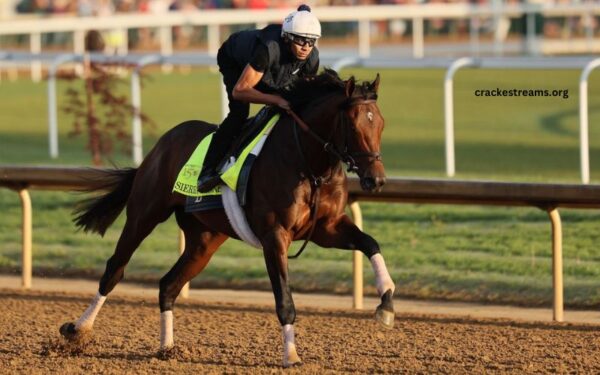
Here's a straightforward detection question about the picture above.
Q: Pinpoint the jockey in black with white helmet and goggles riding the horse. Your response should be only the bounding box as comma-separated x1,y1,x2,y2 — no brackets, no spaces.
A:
198,5,321,193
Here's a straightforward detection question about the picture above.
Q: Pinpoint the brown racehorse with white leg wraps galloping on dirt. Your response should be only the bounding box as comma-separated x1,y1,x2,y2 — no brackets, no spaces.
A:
60,70,394,367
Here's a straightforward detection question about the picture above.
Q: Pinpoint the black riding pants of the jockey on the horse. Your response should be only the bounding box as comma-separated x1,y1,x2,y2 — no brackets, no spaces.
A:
204,49,250,168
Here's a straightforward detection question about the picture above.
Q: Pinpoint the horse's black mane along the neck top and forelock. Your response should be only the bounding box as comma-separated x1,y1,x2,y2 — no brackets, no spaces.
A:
283,68,375,110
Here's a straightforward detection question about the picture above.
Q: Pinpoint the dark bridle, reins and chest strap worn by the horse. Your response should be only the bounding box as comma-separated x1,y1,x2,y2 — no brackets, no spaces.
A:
287,98,381,259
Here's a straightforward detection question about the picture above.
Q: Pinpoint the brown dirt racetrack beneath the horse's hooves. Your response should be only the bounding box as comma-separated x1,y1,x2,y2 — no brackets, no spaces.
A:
0,290,600,374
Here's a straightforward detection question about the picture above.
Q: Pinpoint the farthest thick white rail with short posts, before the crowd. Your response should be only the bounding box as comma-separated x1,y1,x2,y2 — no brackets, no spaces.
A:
0,3,600,80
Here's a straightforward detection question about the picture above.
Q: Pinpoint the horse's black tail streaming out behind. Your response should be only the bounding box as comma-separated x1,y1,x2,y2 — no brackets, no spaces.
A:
73,168,137,236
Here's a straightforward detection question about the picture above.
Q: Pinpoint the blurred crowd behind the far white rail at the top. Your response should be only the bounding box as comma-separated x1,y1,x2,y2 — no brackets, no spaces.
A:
7,0,600,48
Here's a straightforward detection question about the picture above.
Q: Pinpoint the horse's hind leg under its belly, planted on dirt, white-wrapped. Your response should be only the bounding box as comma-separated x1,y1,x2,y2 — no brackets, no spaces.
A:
159,212,228,351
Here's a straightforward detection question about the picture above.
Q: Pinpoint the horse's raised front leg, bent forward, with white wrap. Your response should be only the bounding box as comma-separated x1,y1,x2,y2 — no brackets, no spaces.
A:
312,215,396,328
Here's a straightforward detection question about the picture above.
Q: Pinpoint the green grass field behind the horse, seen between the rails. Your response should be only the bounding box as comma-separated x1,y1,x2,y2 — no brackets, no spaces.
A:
0,69,600,307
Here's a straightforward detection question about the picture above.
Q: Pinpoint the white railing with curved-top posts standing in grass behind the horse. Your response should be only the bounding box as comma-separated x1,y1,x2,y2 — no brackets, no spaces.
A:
0,53,600,184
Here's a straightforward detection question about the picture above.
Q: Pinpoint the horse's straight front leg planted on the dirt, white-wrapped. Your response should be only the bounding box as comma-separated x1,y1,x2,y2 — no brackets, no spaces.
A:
262,227,302,367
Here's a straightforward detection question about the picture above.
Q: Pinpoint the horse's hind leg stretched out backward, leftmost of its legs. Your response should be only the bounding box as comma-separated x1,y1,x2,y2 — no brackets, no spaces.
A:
60,207,170,340
